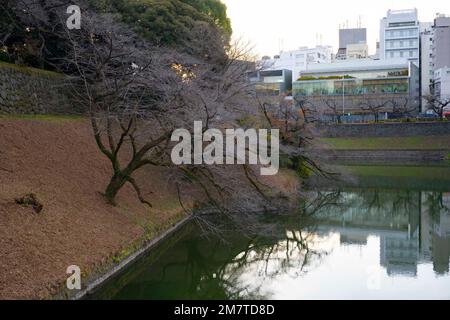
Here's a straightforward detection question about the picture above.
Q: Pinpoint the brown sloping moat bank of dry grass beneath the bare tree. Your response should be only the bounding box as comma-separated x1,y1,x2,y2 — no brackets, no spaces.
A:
0,116,297,299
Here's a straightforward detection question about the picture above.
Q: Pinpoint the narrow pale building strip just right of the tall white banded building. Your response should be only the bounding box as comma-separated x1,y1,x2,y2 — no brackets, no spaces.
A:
420,23,434,112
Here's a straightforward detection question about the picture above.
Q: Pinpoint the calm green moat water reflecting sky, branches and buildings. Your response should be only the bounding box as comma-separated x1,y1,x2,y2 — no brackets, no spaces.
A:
93,189,450,299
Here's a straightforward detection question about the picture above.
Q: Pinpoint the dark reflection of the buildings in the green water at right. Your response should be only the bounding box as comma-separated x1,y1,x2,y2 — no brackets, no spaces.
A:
314,190,450,277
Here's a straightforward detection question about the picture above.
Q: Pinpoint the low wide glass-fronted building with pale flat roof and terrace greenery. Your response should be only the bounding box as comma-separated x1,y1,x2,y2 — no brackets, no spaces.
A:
292,59,420,119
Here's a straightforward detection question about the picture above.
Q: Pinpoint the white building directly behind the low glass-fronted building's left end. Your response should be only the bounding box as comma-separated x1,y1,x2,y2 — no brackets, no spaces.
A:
262,46,333,79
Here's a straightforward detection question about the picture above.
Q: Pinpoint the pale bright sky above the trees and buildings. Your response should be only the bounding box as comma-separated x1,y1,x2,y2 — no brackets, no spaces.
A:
222,0,450,56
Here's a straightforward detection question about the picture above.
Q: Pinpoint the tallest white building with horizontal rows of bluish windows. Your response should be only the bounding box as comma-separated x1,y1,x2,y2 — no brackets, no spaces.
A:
380,9,420,66
